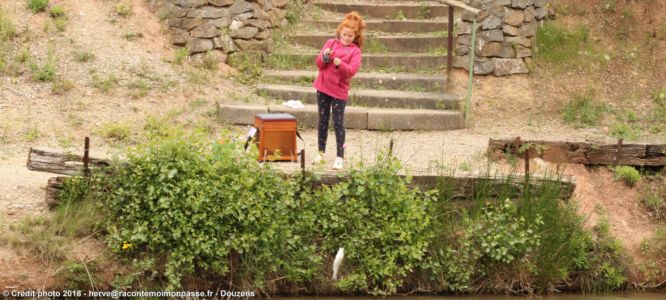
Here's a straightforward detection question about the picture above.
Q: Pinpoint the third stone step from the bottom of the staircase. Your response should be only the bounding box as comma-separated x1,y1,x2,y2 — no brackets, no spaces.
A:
263,70,446,92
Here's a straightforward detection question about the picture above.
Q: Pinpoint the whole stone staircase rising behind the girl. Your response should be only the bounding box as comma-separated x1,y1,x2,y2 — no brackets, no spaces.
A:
220,0,464,130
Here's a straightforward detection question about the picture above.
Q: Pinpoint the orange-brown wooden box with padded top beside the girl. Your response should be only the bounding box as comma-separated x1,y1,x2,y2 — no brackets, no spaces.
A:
254,114,298,161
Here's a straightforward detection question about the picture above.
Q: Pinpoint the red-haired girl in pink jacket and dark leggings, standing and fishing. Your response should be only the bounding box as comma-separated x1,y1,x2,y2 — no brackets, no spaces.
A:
313,11,365,170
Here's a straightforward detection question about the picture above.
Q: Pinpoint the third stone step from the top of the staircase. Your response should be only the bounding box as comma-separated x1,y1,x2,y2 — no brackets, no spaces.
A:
290,33,446,53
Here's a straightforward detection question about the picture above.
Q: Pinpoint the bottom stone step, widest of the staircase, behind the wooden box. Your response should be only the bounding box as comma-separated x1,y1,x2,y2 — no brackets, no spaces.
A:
218,103,465,130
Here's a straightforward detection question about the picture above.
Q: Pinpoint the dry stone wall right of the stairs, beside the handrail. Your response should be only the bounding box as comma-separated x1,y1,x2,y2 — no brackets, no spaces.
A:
454,0,550,76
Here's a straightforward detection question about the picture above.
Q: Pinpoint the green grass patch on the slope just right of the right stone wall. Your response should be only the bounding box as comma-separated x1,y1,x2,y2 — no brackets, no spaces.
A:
534,22,594,66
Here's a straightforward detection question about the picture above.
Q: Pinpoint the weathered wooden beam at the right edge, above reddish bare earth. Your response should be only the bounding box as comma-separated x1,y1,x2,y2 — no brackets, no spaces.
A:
488,139,666,166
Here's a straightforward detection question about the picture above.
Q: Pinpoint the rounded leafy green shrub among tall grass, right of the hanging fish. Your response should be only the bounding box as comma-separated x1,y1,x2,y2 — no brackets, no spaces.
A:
472,199,543,264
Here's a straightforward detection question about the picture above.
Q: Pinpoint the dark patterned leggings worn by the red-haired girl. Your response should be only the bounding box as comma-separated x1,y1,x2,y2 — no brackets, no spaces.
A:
317,91,347,157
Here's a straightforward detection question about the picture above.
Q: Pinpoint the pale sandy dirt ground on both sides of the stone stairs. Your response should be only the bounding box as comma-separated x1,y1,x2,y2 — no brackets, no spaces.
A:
0,0,666,289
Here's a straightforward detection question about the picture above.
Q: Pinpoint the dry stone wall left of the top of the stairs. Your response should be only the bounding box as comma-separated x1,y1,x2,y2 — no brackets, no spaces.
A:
150,0,289,57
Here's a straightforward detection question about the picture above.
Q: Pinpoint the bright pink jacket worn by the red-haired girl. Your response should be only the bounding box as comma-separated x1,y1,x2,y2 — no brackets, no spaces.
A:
312,39,361,101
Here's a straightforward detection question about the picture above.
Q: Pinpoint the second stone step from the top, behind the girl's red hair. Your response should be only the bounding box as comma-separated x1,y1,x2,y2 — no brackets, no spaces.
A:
302,18,449,32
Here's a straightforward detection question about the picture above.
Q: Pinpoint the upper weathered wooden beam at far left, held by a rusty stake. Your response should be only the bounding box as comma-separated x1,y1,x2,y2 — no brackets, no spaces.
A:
27,147,111,175
